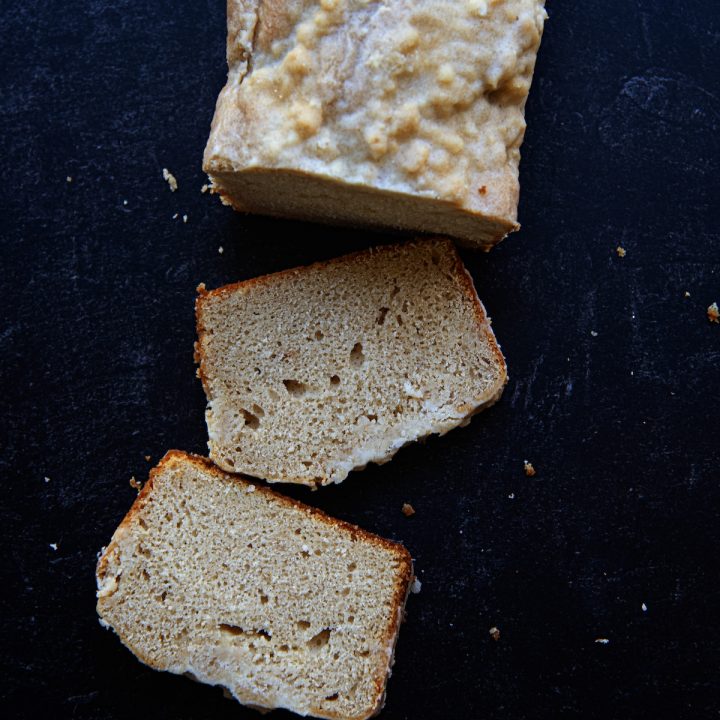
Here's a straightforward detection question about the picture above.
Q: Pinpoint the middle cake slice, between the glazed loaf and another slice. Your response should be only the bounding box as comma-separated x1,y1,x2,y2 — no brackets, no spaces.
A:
196,240,506,485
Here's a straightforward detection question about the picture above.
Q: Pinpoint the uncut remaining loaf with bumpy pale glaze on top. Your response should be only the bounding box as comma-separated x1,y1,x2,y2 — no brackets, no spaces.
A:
203,0,546,249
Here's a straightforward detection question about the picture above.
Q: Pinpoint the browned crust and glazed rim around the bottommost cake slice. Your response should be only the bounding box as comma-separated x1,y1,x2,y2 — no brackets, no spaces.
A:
96,450,413,720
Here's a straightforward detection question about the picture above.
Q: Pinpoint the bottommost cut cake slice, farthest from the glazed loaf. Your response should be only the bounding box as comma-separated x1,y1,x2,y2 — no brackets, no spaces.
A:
97,451,412,718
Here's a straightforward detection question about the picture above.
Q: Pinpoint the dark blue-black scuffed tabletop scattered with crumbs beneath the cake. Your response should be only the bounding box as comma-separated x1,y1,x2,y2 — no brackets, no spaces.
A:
0,0,720,720
